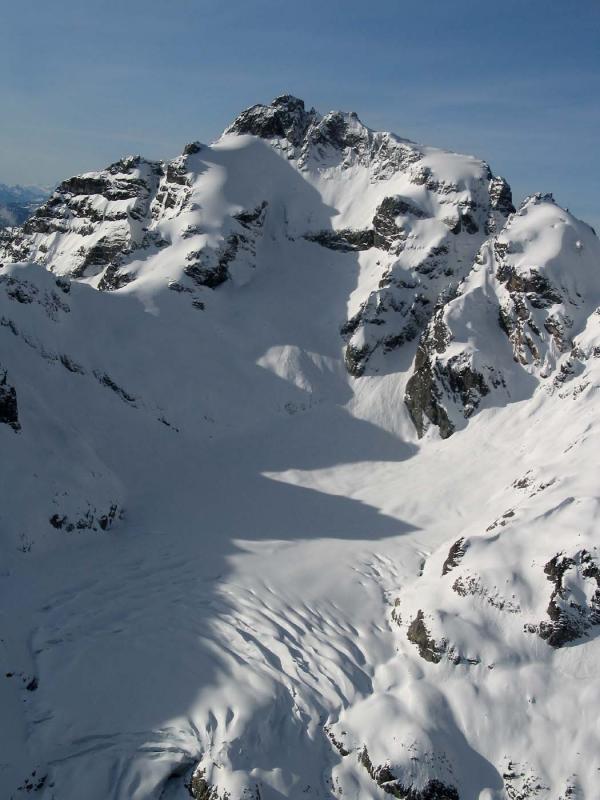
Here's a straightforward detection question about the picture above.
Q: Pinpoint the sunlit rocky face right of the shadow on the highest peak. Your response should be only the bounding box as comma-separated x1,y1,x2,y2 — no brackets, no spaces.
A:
227,96,514,377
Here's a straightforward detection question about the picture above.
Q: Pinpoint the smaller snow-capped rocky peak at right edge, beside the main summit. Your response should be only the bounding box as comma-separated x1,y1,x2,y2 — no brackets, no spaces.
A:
406,195,600,437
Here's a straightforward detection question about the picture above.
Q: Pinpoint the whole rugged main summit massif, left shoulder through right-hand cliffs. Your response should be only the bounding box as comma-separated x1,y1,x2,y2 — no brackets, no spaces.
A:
0,95,512,376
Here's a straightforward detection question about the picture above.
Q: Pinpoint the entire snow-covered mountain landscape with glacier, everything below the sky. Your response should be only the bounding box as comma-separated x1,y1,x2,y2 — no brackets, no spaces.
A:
0,95,600,800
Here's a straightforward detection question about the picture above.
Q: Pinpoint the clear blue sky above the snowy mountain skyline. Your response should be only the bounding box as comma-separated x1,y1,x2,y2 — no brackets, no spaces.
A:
0,0,600,229
